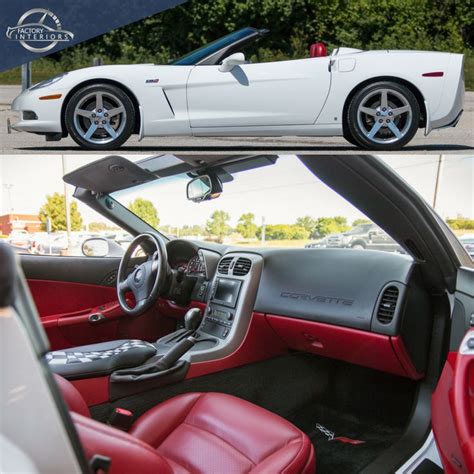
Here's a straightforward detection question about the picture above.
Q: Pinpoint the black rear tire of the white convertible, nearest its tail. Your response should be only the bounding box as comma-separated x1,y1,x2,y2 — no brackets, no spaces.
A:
345,81,420,151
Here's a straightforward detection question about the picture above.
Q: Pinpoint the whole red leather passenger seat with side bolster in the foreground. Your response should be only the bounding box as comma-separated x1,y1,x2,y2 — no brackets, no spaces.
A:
57,377,315,474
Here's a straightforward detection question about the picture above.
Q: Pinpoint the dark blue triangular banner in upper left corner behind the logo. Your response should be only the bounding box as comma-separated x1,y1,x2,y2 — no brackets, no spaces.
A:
0,0,186,71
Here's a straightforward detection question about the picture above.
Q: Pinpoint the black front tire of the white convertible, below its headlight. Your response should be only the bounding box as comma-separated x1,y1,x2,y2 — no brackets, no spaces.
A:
65,83,135,150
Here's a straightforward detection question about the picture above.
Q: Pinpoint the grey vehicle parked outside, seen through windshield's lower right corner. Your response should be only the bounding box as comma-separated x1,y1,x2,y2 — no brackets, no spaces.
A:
327,223,404,253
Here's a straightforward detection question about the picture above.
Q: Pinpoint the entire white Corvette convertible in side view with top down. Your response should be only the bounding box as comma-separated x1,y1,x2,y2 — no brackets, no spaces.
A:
12,28,464,150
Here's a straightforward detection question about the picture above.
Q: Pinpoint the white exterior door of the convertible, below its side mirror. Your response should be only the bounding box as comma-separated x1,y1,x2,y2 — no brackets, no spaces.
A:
187,57,331,128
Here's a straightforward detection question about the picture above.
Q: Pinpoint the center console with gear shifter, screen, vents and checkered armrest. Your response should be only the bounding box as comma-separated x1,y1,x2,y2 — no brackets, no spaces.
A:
48,252,263,401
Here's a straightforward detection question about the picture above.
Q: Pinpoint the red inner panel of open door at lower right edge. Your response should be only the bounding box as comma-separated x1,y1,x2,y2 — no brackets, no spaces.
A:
432,331,474,474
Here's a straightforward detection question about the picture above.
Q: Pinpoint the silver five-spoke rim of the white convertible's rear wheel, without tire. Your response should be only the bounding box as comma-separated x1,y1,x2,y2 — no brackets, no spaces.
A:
357,89,413,144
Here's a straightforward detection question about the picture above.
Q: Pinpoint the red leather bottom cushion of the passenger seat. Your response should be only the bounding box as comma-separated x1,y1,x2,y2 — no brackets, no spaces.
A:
130,393,314,474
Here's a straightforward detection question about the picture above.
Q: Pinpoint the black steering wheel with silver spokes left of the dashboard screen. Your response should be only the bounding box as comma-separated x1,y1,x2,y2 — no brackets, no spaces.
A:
117,233,170,316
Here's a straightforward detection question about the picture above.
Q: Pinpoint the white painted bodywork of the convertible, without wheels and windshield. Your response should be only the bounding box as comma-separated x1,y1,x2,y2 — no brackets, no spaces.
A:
12,48,464,142
